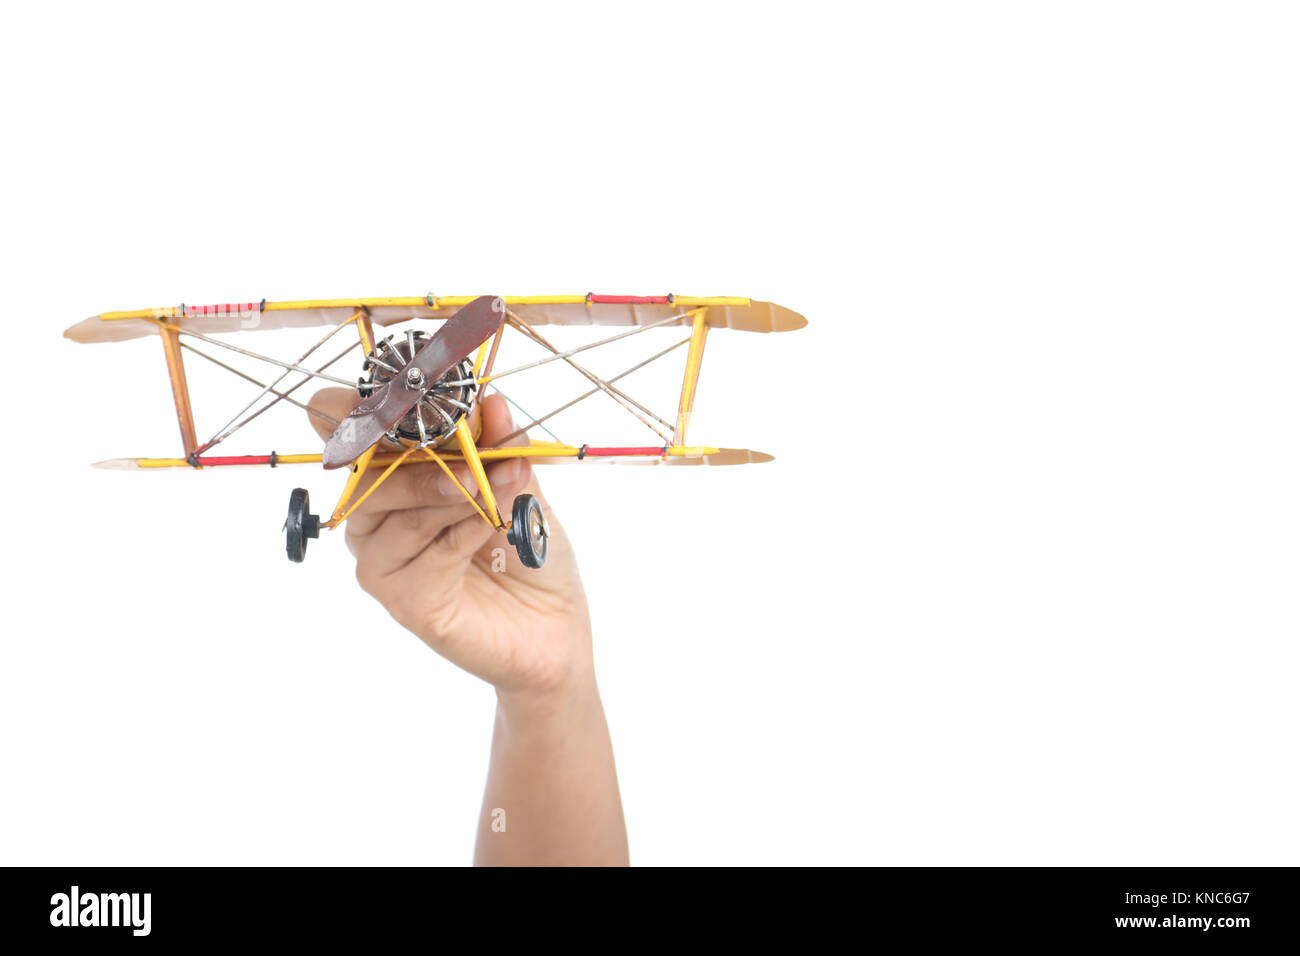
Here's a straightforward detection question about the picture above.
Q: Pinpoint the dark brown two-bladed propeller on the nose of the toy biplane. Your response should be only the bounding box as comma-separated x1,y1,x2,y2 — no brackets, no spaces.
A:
321,295,506,468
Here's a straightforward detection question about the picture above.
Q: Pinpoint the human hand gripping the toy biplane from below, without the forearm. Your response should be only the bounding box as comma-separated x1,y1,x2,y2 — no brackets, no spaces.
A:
311,389,594,701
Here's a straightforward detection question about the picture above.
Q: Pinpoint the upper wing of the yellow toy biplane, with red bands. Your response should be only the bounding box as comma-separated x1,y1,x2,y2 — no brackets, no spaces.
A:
64,295,807,342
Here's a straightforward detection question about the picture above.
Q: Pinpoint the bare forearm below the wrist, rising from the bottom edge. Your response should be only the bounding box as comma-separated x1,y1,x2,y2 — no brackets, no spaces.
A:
475,676,628,866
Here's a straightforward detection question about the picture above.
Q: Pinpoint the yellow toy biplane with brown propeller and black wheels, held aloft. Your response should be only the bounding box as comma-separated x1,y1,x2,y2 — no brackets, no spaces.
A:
64,294,807,567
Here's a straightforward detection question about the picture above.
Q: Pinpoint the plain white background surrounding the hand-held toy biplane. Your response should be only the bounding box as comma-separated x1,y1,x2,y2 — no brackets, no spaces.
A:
0,3,1300,864
